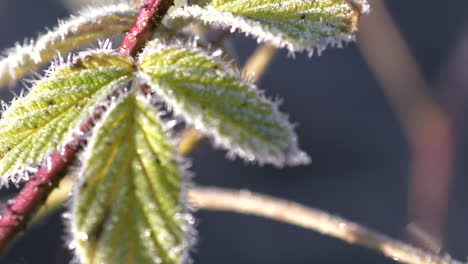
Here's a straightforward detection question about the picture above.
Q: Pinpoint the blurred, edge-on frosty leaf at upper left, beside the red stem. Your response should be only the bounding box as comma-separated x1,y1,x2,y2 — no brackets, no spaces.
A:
0,4,138,86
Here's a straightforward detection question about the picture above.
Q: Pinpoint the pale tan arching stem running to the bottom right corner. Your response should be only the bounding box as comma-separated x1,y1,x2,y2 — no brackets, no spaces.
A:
188,187,461,264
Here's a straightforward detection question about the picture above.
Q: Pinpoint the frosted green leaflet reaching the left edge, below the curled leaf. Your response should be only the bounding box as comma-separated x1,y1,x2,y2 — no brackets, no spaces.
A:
0,50,134,185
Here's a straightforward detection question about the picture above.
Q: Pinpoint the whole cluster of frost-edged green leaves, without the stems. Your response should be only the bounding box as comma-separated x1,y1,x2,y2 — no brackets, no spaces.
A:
0,0,368,263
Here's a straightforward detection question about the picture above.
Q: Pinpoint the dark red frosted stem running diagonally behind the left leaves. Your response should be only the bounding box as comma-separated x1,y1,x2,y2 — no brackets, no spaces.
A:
0,0,173,252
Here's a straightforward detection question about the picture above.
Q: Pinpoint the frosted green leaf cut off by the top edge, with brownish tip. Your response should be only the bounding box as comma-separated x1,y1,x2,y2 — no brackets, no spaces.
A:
170,0,369,55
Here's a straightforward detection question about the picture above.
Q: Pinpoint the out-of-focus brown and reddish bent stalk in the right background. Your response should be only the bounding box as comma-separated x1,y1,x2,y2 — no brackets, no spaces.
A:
358,0,454,251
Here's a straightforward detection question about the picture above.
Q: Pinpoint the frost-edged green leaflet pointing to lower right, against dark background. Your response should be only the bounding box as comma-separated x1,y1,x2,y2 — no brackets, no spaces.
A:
139,41,309,167
